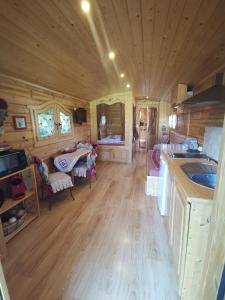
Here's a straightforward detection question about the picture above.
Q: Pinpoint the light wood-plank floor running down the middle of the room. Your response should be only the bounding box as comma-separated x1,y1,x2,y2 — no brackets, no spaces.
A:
3,153,179,300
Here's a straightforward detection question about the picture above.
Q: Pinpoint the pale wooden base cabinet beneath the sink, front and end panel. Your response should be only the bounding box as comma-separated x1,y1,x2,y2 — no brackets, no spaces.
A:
168,175,213,300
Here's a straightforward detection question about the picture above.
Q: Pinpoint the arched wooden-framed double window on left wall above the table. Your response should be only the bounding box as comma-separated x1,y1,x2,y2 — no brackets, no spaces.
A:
29,101,73,146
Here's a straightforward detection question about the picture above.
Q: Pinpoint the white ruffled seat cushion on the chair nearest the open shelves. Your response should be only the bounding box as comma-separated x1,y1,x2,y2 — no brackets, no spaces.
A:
48,172,73,193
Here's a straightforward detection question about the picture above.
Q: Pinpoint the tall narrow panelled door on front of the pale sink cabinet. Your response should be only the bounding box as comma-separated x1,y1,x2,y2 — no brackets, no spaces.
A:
172,184,190,287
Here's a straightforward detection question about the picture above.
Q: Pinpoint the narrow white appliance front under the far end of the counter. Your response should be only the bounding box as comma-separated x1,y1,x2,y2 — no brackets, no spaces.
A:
157,156,169,216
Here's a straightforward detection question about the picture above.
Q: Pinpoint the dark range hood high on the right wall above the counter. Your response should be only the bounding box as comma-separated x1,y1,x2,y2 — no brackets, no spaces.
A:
182,73,225,106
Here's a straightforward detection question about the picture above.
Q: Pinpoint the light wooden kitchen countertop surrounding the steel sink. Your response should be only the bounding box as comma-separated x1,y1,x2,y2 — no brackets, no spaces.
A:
162,151,214,204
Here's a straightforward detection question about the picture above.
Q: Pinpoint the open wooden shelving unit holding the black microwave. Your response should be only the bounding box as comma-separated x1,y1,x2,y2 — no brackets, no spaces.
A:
0,165,40,257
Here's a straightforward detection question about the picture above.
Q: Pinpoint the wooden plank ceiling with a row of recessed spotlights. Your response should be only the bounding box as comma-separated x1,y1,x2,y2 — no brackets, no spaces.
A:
0,0,225,100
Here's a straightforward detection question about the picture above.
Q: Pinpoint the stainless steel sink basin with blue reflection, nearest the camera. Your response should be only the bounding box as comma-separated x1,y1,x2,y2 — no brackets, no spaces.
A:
181,162,217,189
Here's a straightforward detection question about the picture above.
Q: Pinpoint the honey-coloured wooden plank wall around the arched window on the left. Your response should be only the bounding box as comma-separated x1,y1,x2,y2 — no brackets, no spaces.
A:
0,74,90,159
